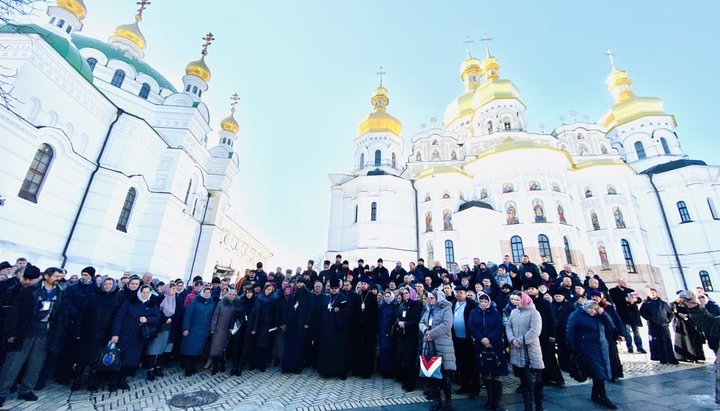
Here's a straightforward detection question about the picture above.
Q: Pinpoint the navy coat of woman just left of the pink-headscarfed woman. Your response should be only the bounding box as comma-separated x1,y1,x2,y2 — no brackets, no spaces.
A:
468,304,508,377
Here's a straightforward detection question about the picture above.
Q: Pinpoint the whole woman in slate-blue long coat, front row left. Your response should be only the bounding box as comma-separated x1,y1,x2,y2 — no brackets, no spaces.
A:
180,287,215,377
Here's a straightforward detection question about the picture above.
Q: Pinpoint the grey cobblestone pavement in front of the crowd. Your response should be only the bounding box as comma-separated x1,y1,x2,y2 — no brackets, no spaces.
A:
0,354,714,411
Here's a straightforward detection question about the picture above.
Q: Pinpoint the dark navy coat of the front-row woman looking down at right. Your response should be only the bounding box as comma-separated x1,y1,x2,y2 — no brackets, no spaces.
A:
566,308,613,381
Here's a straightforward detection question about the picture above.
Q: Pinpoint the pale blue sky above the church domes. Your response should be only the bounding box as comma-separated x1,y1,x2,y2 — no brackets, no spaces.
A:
26,0,720,267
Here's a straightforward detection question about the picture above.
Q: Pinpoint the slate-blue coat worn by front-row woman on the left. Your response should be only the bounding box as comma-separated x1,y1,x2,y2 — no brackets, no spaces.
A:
180,294,215,356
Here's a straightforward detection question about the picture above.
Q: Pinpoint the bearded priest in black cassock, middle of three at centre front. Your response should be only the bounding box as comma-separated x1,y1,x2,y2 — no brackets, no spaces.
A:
318,278,351,380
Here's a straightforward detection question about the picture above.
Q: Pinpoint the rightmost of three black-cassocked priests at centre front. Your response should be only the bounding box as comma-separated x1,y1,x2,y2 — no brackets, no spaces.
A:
350,275,379,378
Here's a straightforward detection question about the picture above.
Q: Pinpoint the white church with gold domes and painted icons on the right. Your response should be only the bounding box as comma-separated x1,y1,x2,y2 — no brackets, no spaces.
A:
327,48,720,295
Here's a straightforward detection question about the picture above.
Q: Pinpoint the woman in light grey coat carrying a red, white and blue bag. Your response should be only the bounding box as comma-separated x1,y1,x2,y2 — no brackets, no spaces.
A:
420,289,457,411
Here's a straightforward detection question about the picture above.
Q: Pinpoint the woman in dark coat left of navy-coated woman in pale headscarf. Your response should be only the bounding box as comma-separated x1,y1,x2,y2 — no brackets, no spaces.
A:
73,277,120,391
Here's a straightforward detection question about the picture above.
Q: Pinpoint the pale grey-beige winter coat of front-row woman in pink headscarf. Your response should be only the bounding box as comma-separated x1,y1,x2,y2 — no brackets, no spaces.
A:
505,303,545,369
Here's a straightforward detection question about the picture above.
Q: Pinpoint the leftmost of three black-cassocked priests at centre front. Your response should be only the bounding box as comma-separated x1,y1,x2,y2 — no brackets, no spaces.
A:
281,276,312,373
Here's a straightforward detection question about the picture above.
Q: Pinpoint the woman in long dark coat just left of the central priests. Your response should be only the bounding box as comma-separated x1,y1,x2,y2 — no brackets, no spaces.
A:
248,282,280,372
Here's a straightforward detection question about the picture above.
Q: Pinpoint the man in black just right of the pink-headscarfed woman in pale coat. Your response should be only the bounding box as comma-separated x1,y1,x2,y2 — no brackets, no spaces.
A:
524,283,565,388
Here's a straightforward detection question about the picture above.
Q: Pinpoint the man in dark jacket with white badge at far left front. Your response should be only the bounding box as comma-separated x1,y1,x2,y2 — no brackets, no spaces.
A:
0,267,65,407
